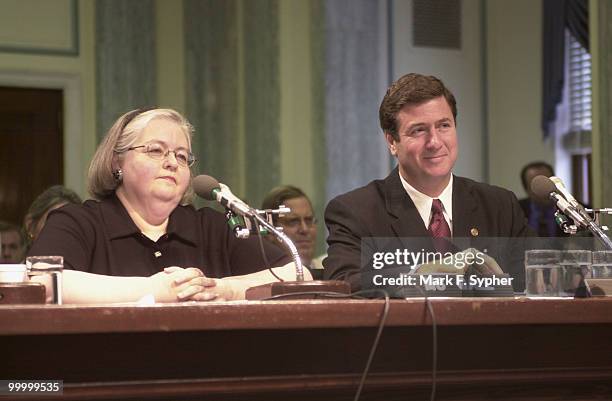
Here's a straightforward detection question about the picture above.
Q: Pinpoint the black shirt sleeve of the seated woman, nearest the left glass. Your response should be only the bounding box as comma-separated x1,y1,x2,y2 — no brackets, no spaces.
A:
28,205,95,271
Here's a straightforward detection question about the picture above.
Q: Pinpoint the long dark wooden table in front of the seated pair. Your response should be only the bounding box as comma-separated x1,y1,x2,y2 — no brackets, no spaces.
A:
0,298,612,400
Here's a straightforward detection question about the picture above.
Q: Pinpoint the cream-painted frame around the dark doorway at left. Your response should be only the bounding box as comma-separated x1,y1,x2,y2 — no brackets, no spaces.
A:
0,70,86,195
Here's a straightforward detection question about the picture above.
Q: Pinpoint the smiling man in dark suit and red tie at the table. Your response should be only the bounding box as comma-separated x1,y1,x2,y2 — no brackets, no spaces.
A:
323,74,531,290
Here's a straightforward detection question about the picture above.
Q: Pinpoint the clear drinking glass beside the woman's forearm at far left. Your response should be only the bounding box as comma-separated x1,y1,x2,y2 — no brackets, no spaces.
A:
26,256,64,305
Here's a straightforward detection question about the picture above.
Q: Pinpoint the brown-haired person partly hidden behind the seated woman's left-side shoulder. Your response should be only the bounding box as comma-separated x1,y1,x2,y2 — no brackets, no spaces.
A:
23,185,82,253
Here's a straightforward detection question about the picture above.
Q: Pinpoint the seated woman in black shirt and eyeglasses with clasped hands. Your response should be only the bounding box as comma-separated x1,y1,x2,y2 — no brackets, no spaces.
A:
29,109,306,302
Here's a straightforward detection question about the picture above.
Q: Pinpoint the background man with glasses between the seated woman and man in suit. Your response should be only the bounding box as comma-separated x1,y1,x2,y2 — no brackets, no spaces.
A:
261,185,323,279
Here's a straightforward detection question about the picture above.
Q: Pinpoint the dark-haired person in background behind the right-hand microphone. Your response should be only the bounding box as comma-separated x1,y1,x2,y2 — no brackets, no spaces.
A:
519,161,565,237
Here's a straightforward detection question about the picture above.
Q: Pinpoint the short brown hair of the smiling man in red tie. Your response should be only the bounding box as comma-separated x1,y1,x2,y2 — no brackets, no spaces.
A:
378,73,457,140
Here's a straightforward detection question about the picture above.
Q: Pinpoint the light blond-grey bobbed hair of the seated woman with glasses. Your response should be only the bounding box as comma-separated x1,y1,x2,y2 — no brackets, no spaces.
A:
87,108,193,205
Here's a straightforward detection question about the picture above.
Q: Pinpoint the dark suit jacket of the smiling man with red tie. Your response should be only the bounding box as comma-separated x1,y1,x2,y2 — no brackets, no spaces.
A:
323,168,533,290
